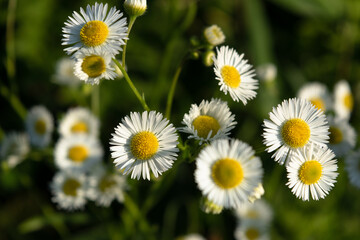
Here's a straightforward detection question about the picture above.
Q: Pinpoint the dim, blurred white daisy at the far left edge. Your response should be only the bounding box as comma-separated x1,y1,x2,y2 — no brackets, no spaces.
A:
0,132,30,168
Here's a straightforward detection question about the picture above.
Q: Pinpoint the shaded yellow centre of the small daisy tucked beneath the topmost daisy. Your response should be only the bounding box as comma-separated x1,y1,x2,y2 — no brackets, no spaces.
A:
81,55,106,78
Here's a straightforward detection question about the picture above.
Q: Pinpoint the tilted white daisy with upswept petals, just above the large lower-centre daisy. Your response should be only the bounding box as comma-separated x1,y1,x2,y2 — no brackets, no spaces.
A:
179,99,236,144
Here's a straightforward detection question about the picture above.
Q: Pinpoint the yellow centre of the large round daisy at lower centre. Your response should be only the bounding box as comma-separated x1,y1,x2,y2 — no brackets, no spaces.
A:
211,158,244,189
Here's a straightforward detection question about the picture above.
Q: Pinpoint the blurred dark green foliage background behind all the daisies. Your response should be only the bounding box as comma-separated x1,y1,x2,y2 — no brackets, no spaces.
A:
0,0,360,240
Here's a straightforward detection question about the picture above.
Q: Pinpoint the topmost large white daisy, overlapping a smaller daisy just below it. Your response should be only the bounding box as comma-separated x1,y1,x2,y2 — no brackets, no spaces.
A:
62,3,127,55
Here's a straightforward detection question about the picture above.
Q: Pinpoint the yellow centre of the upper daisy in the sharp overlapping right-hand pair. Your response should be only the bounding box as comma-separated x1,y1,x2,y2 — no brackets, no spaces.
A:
281,118,310,148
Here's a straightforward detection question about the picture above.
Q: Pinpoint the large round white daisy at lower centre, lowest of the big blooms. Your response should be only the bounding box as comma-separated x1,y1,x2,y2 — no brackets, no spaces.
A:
195,139,263,208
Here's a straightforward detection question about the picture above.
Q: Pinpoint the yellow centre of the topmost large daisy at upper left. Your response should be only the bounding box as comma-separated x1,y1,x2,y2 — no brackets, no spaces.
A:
80,20,109,47
